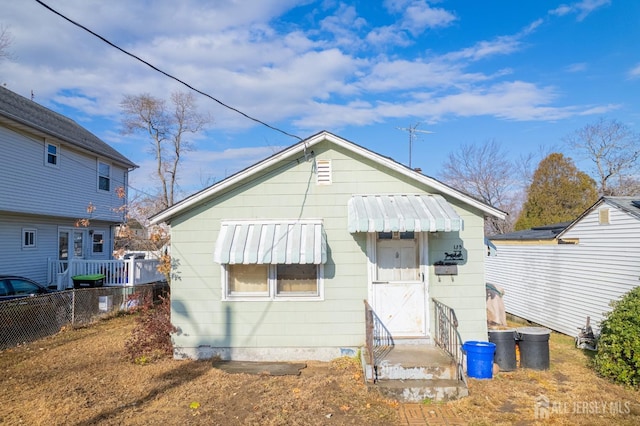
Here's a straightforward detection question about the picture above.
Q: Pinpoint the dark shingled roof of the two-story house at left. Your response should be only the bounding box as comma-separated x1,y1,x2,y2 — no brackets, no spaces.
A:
0,86,138,168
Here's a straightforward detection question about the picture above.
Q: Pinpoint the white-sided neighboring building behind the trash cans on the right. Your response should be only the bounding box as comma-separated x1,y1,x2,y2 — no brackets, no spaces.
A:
486,197,640,336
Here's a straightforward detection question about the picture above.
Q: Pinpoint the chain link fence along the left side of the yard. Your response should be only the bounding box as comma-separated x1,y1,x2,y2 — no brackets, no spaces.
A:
0,283,169,350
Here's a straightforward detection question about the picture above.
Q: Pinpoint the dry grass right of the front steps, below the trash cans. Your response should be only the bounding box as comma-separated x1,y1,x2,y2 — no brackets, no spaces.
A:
447,322,640,425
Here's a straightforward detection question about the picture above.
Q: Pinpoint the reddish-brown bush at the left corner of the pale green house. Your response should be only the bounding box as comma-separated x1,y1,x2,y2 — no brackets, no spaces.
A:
125,296,176,365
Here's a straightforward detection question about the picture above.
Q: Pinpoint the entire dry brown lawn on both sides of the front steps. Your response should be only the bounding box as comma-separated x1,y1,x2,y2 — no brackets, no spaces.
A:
0,316,640,425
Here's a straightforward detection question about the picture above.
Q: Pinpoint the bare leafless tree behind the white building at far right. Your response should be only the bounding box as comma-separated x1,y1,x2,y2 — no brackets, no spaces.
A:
563,118,640,195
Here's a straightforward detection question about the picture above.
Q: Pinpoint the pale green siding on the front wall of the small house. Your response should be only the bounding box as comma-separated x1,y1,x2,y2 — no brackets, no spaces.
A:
171,142,486,356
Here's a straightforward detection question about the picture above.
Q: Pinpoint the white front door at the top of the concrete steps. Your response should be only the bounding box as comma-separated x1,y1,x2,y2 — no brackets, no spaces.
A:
369,232,429,337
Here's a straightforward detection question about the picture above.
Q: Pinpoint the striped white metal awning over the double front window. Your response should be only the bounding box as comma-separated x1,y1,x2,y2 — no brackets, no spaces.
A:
213,220,327,265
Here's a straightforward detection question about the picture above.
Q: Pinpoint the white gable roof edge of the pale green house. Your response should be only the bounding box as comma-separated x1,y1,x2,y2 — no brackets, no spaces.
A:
150,131,506,224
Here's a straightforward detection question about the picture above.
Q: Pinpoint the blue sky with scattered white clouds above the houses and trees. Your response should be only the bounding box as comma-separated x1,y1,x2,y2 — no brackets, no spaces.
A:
0,0,640,200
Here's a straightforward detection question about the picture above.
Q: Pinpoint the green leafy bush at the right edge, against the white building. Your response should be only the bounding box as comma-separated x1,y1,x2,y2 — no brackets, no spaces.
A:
594,287,640,388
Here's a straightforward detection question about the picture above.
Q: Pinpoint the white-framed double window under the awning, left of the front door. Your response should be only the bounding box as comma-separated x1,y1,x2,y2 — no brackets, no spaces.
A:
222,264,323,300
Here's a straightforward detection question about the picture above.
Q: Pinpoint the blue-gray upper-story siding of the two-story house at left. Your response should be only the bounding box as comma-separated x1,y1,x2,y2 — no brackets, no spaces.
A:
0,127,127,222
